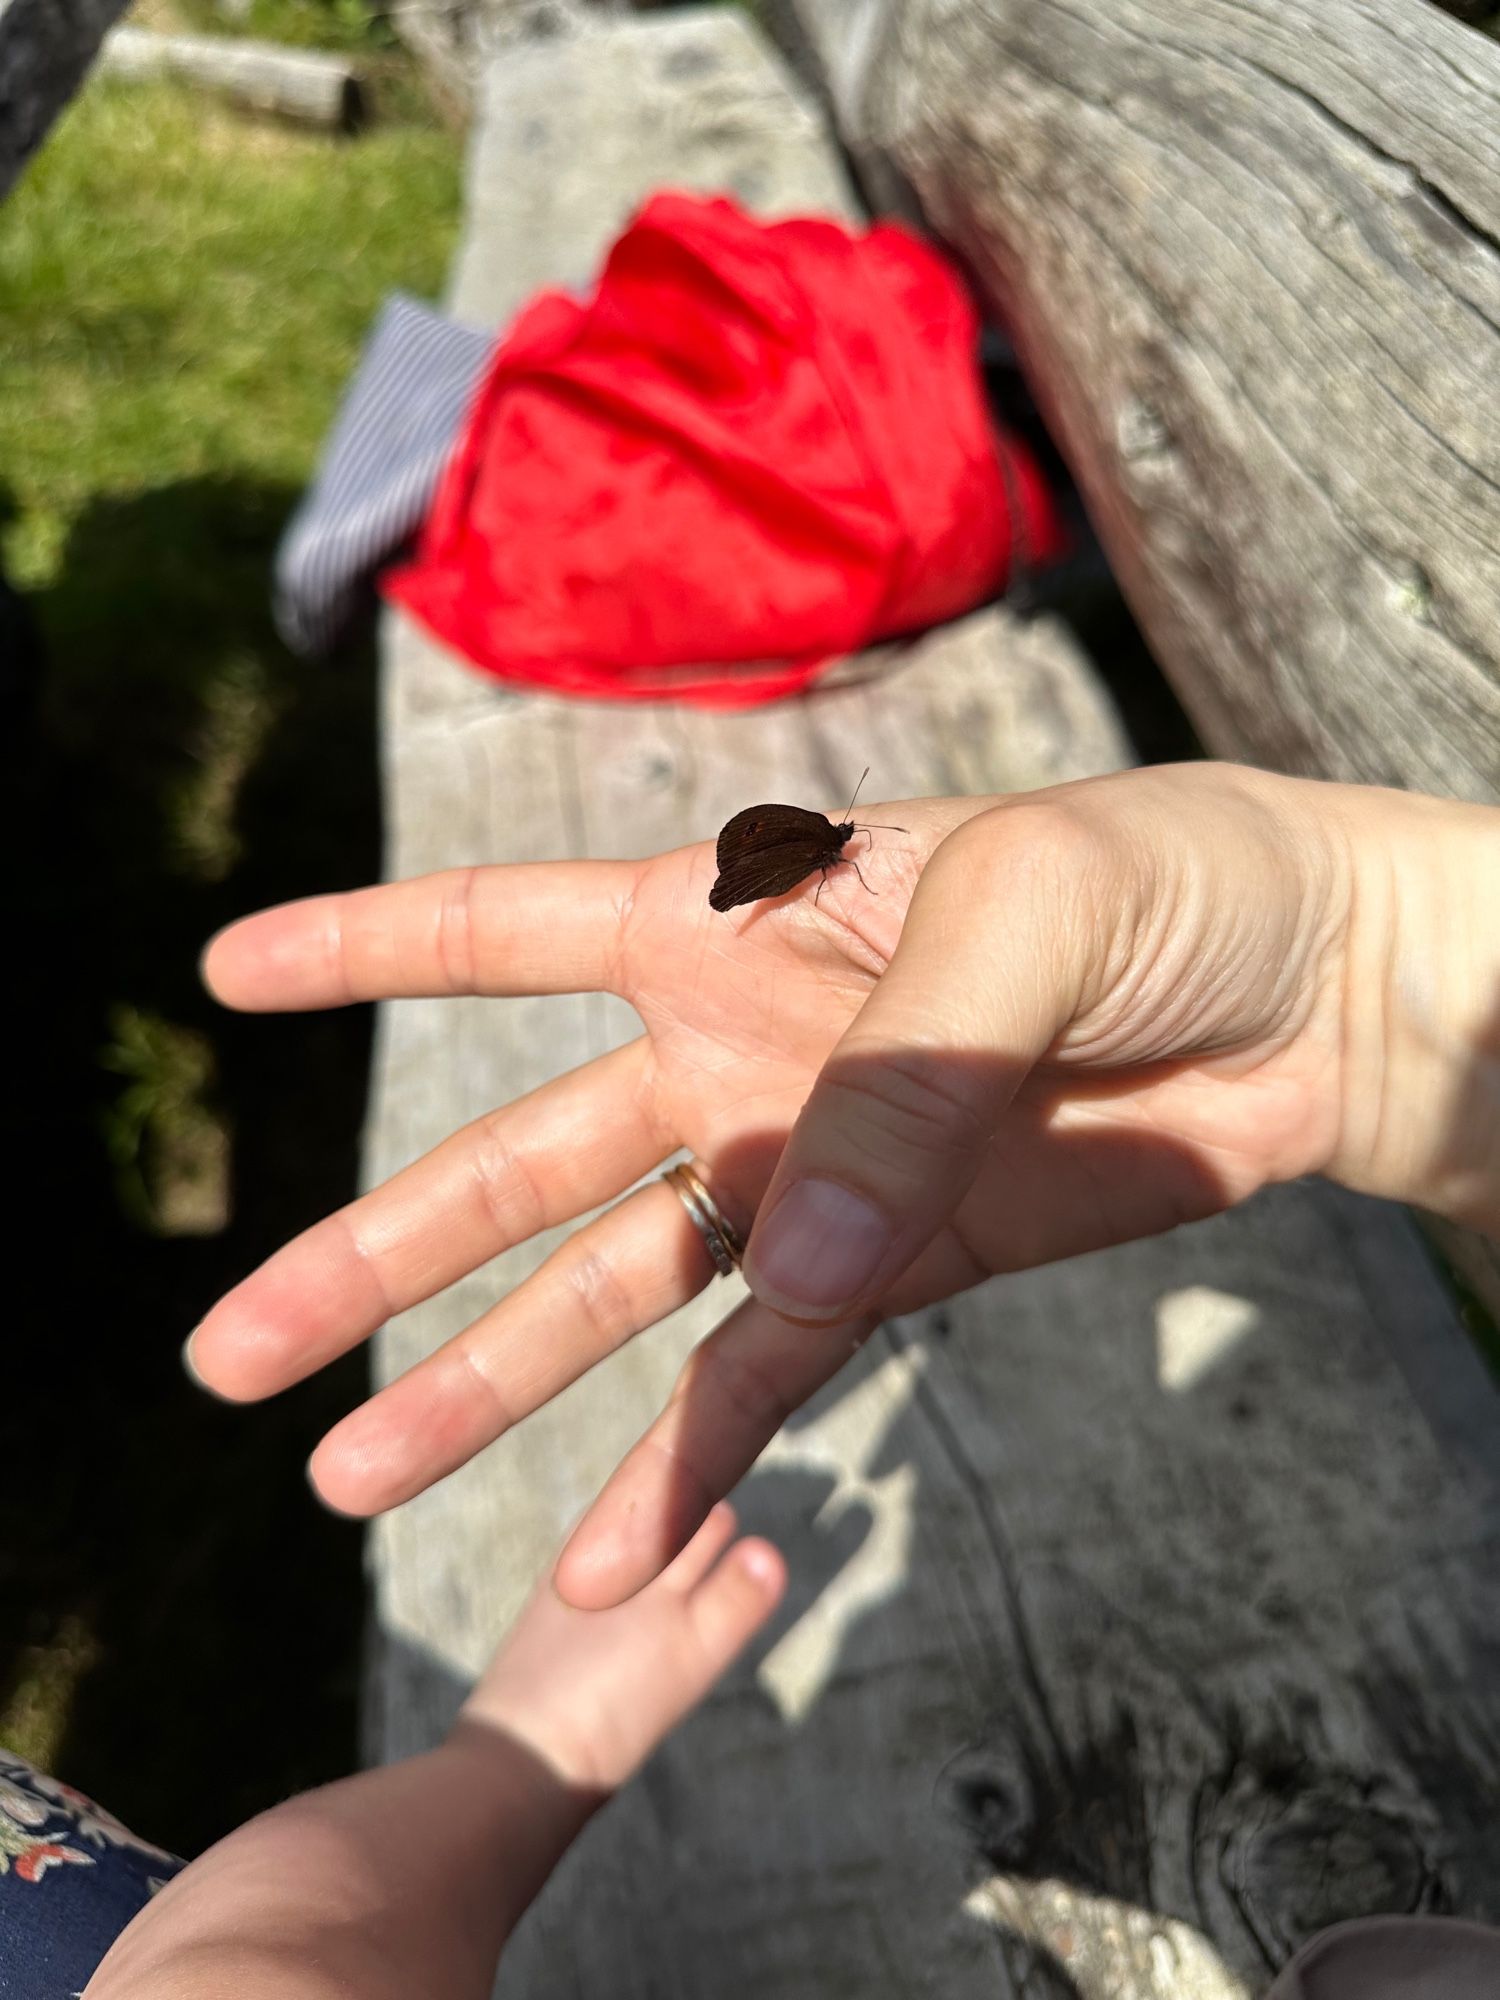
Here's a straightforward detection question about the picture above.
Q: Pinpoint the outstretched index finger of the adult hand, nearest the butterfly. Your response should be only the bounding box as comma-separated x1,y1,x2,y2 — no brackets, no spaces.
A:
202,862,640,1014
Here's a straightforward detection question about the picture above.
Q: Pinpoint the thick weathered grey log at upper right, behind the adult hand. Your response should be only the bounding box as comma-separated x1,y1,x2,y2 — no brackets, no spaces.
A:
792,0,1500,1320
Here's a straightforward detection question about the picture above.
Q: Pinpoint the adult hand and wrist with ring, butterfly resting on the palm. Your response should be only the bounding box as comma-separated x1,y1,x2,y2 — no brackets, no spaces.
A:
192,764,1500,1606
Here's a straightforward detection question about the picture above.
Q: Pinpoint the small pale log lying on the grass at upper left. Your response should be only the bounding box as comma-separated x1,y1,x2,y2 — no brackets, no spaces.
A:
100,28,362,132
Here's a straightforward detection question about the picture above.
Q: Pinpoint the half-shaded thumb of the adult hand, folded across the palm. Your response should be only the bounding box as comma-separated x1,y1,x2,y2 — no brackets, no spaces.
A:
744,802,1098,1322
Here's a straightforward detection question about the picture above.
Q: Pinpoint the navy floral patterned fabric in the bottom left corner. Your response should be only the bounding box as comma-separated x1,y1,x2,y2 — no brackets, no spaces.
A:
0,1750,184,2000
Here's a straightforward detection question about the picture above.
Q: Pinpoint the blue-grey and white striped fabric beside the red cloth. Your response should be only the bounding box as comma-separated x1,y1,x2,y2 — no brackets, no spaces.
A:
274,292,492,658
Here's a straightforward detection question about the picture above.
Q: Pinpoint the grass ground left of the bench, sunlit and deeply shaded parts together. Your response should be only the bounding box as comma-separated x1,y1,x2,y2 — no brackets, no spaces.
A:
0,70,460,1848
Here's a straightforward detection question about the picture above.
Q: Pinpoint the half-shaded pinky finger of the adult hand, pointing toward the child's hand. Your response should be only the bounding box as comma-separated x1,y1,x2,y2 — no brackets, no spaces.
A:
554,1300,878,1610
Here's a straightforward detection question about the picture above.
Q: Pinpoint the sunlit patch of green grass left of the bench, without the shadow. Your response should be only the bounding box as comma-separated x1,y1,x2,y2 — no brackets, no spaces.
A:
0,84,456,584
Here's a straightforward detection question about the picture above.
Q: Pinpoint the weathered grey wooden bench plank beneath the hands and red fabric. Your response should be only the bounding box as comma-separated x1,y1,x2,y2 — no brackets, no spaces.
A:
366,16,1500,2000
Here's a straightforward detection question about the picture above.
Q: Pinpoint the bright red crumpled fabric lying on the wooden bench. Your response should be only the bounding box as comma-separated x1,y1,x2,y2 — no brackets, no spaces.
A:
384,194,1060,708
